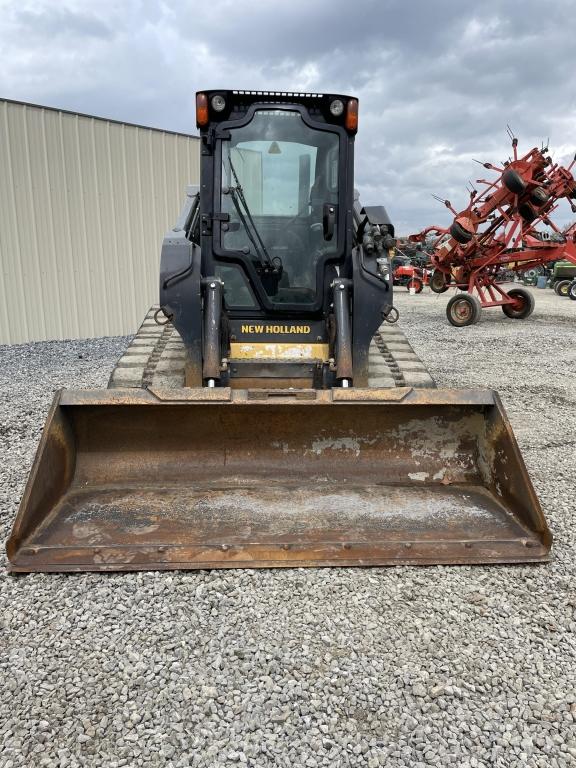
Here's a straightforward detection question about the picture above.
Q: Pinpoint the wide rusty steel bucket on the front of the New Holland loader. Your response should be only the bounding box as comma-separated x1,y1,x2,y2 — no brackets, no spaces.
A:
7,388,551,571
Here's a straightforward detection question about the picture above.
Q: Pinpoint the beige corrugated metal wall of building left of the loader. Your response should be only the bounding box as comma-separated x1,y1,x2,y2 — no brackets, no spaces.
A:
0,100,199,344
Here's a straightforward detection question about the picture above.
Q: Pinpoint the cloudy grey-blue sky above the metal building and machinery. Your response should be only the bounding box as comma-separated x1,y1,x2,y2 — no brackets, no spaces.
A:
0,0,576,234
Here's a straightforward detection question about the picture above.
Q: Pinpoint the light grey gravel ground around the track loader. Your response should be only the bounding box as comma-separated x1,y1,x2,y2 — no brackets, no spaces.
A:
0,289,576,768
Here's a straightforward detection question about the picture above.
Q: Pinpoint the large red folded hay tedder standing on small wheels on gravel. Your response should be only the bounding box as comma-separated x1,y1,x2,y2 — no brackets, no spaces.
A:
410,137,576,327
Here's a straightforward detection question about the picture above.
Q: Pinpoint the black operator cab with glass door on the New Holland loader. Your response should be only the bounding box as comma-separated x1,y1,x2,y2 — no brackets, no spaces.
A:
197,91,358,316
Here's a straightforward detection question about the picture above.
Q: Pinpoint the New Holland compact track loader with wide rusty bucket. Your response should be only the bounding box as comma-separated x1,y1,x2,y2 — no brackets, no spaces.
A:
7,91,551,571
